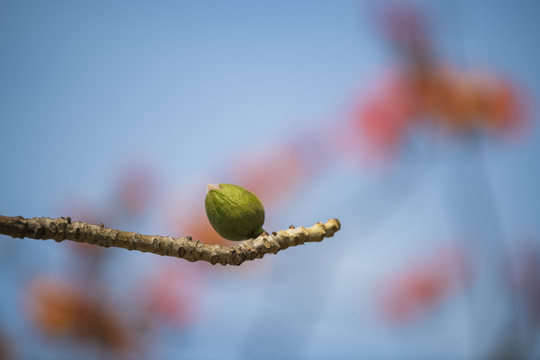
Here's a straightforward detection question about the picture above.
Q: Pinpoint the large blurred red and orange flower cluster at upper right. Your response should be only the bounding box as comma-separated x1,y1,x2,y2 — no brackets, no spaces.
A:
350,3,527,157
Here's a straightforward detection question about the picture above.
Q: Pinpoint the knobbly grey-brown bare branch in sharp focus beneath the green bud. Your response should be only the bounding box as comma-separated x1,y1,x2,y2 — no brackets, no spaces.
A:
0,215,341,265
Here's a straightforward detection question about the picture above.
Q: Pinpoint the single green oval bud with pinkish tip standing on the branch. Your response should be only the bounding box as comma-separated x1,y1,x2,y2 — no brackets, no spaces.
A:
204,184,264,241
